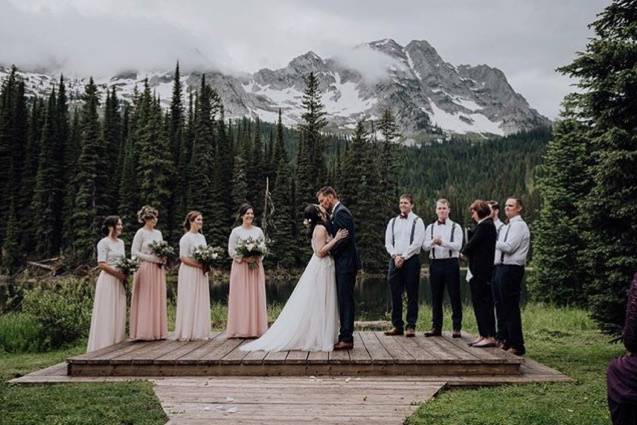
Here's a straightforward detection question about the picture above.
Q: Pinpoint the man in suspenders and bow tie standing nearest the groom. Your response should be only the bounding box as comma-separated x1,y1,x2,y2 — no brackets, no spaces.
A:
385,193,425,337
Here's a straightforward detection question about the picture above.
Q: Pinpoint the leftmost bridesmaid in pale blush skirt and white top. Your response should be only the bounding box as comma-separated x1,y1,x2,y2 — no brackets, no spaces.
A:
86,215,126,352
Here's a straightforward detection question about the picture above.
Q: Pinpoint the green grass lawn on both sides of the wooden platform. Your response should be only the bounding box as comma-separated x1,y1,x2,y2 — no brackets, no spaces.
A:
0,305,623,425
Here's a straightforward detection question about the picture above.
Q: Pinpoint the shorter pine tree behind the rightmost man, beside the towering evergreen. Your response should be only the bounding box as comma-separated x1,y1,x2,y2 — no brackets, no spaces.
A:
529,102,590,305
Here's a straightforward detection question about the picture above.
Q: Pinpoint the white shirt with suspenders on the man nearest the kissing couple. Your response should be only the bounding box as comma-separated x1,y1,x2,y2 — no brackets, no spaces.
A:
385,212,425,260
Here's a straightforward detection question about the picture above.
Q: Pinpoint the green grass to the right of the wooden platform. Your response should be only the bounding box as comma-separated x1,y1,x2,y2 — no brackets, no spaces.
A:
406,304,623,425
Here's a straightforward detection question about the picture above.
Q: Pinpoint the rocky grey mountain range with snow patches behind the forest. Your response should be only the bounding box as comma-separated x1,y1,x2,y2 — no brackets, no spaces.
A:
0,39,550,139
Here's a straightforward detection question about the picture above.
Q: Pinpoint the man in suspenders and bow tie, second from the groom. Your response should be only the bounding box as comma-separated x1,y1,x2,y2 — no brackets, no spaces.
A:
423,199,464,338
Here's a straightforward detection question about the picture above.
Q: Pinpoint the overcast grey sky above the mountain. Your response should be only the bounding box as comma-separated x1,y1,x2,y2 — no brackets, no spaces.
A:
0,0,610,118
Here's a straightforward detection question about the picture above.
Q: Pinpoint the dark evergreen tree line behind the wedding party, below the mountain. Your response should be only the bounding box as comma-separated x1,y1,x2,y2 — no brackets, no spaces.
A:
0,64,549,273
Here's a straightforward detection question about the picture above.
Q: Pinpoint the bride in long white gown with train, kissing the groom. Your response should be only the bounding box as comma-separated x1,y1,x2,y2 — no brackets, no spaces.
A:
239,205,347,351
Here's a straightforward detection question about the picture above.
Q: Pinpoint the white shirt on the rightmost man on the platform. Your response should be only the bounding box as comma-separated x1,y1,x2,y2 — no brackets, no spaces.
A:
495,215,531,266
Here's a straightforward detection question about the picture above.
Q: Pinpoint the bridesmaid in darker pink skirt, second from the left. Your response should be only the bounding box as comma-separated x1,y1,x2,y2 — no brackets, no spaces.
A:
130,205,168,340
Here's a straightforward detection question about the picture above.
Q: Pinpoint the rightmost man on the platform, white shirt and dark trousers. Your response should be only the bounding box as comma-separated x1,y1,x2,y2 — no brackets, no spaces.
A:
494,197,531,356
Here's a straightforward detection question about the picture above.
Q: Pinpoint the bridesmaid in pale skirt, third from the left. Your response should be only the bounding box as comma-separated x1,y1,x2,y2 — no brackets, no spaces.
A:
175,211,210,341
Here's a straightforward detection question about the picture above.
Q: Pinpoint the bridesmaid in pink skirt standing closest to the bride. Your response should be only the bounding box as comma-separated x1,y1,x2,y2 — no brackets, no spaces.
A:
226,204,268,338
